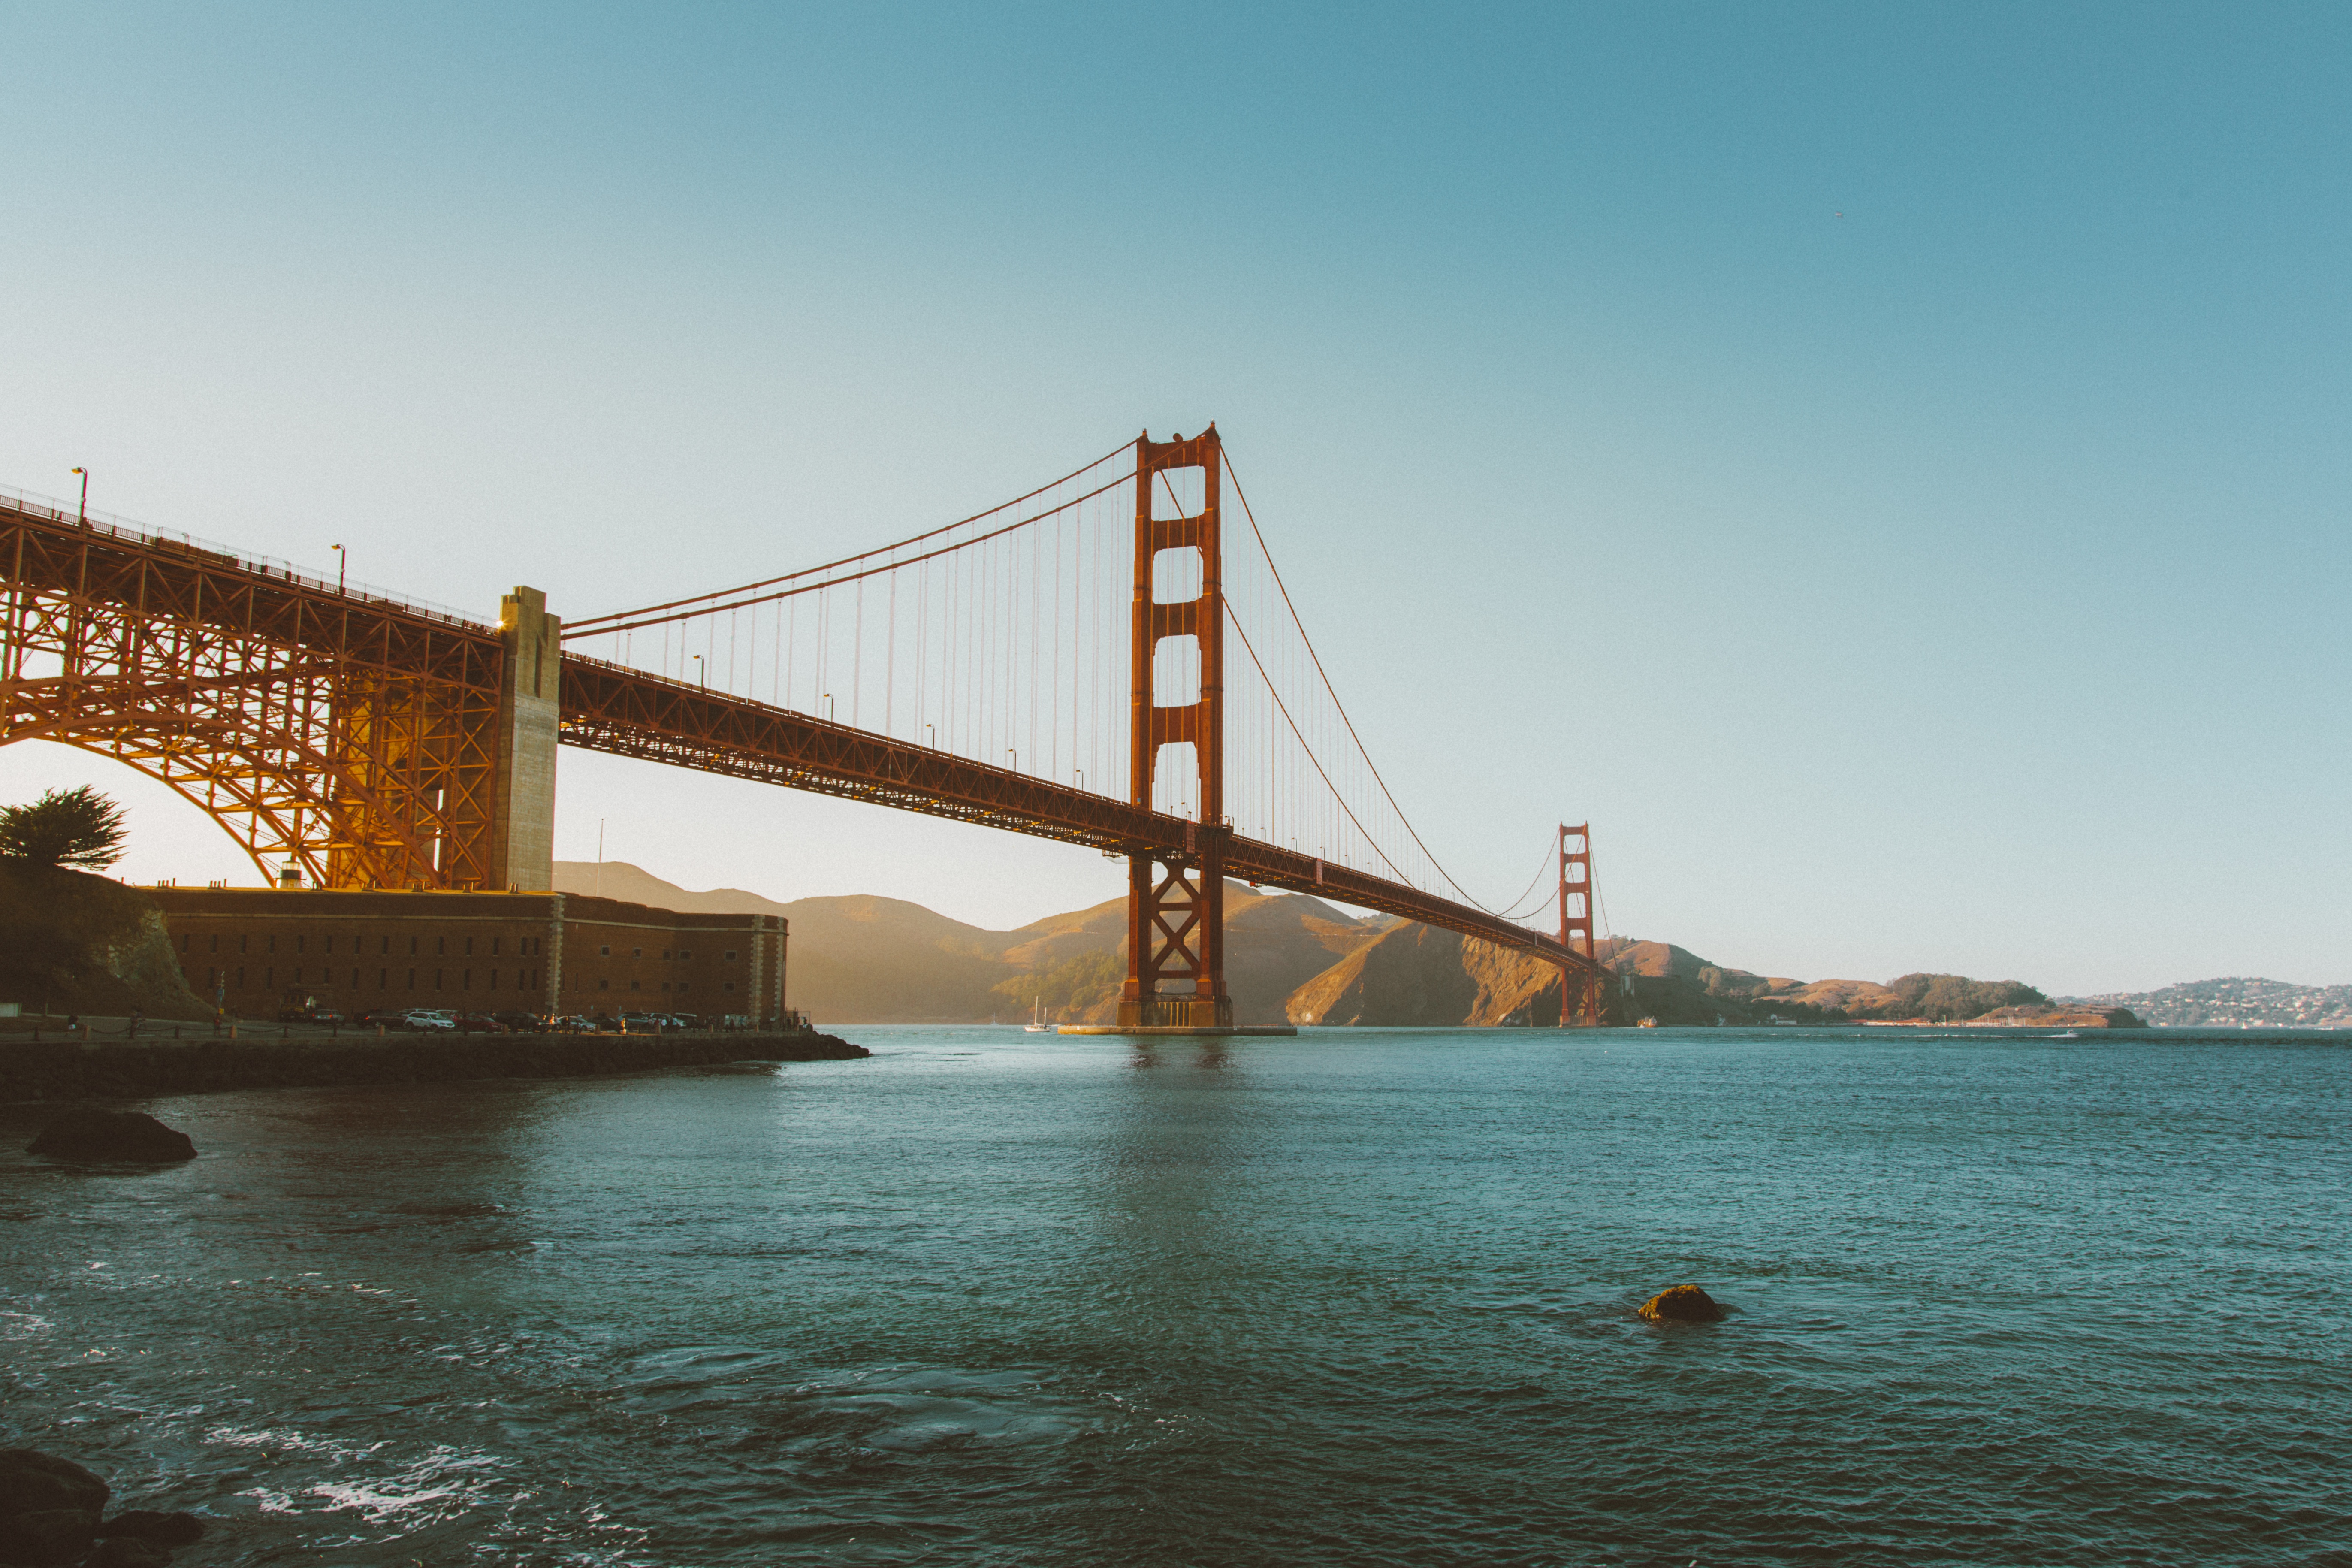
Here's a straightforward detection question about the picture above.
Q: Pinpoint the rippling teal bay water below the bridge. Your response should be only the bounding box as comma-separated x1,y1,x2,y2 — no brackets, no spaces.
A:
0,1027,2352,1568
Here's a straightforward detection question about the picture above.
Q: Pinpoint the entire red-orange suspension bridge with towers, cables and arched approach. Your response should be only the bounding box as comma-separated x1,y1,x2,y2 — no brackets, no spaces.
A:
0,426,1604,1032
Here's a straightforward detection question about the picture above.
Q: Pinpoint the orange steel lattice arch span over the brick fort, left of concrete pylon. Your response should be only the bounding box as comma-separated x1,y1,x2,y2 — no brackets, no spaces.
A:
0,501,503,886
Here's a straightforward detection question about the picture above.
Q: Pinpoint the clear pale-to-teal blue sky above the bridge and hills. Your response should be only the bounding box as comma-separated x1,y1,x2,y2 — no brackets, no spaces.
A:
0,5,2352,992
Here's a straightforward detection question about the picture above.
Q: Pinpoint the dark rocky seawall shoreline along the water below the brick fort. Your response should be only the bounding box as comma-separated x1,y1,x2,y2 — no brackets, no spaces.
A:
0,1034,873,1103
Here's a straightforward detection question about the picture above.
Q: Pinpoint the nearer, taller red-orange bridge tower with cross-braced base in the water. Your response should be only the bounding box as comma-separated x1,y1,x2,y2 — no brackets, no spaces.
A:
1120,426,1232,1030
